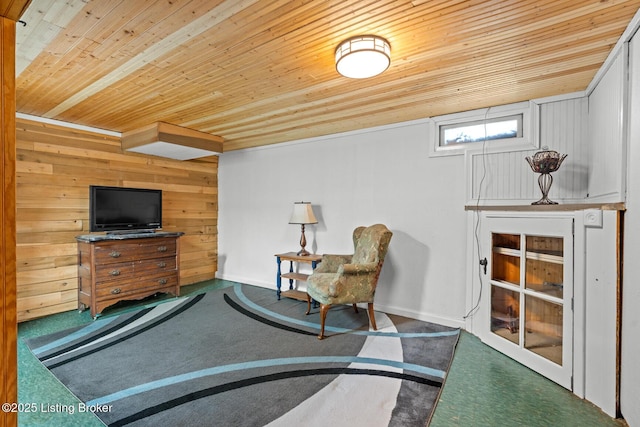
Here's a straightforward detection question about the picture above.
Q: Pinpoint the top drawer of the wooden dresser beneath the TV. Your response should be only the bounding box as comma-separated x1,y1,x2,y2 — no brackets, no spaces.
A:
94,238,176,265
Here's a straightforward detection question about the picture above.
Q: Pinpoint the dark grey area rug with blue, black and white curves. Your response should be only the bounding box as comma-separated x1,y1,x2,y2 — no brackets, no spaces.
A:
27,284,459,427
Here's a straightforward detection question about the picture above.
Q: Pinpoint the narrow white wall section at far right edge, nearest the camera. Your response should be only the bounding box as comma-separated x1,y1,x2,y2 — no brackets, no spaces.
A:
620,31,640,427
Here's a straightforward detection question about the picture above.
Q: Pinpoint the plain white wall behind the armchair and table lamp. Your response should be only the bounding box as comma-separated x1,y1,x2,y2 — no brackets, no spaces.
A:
218,121,467,326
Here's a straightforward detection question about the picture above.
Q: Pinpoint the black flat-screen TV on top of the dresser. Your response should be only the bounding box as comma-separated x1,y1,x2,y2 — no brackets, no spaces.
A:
89,185,162,231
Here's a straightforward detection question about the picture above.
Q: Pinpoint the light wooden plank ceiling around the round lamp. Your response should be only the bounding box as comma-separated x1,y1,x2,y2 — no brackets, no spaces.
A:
16,0,640,151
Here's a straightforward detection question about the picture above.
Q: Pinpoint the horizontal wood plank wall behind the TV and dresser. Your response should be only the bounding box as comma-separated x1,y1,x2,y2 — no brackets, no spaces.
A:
16,118,218,321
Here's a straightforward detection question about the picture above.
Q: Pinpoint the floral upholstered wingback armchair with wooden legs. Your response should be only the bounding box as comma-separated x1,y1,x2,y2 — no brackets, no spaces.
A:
306,224,393,339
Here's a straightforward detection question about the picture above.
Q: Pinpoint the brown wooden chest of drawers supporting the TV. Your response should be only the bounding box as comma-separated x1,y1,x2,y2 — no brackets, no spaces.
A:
77,233,182,317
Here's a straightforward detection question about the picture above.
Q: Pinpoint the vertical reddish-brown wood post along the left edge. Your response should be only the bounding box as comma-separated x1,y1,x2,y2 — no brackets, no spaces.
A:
0,17,18,427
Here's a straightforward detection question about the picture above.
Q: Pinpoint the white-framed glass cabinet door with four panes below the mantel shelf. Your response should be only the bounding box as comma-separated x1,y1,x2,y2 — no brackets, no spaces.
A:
483,216,573,388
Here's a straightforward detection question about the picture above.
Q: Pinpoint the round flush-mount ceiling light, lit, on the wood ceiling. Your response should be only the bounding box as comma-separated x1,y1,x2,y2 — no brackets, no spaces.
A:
336,35,391,79
